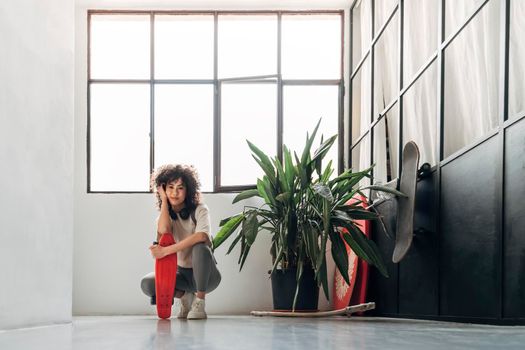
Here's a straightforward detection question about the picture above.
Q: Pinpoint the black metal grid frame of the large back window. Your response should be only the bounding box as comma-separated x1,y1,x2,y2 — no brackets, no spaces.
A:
86,9,345,194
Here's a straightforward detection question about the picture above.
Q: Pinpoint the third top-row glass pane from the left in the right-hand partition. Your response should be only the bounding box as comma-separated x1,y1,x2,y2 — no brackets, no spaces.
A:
403,0,439,86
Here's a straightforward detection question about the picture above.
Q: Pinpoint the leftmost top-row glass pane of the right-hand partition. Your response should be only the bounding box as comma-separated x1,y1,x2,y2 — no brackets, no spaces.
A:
352,0,372,72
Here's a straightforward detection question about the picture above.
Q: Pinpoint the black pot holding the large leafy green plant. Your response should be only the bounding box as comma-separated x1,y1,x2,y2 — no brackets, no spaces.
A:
271,268,319,311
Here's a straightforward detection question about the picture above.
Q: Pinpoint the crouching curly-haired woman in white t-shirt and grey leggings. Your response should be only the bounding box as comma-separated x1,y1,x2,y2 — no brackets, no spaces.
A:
141,164,221,319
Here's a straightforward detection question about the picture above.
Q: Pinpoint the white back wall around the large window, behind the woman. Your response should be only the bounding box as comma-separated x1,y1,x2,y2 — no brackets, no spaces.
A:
73,0,349,315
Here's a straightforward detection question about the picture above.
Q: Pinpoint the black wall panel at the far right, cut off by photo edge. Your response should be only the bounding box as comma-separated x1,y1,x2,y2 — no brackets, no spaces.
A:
503,120,525,318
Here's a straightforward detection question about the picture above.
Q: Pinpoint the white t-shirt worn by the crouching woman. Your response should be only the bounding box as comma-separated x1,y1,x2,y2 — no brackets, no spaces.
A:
157,203,213,268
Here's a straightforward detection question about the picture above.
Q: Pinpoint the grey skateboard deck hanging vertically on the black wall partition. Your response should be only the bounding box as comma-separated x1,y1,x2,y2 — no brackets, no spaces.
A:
392,141,419,263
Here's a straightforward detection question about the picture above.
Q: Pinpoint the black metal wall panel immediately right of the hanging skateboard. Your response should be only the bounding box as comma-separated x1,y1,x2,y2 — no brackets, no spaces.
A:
399,174,439,316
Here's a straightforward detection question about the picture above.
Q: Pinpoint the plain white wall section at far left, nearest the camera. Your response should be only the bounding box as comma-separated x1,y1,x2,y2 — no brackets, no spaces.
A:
0,0,74,329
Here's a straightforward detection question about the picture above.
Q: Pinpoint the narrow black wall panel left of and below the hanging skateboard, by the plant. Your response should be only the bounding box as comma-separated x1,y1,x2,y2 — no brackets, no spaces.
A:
367,200,398,315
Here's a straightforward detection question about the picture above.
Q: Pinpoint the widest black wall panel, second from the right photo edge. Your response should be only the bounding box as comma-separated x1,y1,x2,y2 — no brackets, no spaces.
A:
440,137,501,318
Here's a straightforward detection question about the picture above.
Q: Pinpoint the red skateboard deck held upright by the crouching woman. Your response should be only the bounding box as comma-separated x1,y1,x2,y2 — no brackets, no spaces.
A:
155,233,177,319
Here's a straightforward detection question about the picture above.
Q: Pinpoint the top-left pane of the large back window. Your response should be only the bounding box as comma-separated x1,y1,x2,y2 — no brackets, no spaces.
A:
90,15,150,79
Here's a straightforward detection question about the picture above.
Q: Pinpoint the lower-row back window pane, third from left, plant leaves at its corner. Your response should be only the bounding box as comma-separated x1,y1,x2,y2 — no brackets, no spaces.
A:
221,84,277,186
